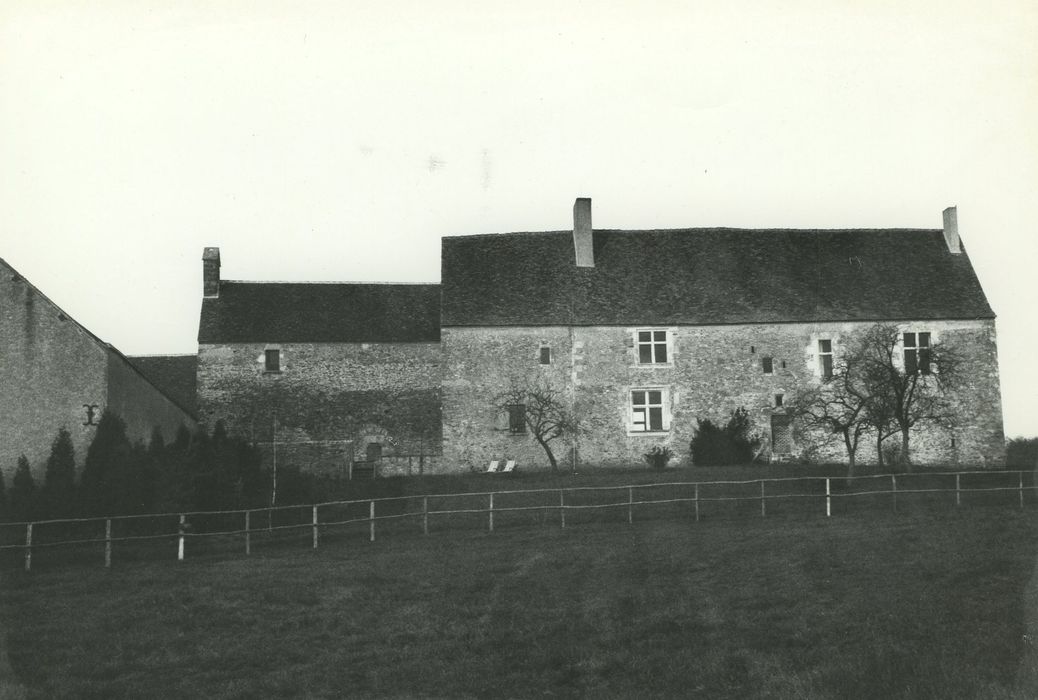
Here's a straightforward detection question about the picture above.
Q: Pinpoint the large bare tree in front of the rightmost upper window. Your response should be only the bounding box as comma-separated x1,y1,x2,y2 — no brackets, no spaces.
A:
851,324,959,466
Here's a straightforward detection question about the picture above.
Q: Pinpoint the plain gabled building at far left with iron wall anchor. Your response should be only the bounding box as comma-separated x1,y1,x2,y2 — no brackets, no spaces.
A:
0,254,196,479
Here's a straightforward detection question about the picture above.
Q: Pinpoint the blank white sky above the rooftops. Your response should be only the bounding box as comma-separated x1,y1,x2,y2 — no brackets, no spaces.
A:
6,0,1038,436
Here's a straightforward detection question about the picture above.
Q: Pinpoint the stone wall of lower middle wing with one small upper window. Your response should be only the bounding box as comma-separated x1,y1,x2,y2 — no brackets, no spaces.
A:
198,343,442,476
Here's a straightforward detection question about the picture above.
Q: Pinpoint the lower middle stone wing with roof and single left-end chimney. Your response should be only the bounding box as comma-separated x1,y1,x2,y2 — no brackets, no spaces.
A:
197,248,441,476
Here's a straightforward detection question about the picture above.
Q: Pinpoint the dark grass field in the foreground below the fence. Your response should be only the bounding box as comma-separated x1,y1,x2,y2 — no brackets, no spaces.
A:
0,508,1038,698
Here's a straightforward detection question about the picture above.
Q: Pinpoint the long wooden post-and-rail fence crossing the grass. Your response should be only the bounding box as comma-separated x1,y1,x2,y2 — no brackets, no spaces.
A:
0,472,1038,571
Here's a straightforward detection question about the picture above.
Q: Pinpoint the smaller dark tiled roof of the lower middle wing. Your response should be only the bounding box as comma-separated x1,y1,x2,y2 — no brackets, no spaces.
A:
198,281,440,343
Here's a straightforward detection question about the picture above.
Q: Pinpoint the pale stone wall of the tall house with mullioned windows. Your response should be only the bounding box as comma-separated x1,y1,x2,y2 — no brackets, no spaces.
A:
441,321,1005,470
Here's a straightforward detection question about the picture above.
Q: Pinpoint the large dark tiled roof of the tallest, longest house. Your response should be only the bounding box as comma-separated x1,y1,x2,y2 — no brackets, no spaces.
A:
442,228,993,326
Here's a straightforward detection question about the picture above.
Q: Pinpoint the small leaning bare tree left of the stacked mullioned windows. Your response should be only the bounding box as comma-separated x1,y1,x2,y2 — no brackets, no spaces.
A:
495,380,580,472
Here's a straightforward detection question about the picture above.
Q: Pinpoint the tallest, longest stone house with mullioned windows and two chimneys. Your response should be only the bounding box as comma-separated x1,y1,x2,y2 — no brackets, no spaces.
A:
440,199,1004,469
